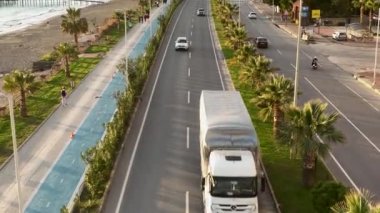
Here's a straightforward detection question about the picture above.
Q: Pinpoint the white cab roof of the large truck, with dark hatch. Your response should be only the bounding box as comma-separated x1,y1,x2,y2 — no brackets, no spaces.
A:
209,150,257,177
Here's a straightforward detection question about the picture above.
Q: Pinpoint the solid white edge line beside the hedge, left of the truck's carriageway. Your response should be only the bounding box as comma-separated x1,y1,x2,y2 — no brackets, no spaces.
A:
116,4,186,213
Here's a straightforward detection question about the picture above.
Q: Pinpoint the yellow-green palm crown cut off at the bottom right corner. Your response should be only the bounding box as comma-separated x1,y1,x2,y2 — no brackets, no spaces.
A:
331,189,380,213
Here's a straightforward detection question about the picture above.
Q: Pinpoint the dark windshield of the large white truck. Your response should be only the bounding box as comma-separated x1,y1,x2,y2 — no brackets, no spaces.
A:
210,176,257,198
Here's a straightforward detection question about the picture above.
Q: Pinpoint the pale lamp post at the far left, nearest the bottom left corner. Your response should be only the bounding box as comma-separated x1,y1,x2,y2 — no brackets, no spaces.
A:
0,93,23,213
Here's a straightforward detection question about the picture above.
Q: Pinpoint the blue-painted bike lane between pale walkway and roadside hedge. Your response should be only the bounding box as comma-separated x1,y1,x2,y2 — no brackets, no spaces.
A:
24,6,166,213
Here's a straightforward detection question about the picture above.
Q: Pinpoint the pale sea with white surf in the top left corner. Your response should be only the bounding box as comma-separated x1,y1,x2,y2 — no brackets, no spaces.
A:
0,0,111,35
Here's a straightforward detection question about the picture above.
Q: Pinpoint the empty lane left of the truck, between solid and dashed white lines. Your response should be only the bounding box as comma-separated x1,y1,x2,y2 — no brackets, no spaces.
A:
122,30,199,212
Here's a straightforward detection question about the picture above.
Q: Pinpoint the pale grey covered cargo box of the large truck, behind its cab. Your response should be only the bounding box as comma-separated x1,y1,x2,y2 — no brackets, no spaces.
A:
200,90,258,148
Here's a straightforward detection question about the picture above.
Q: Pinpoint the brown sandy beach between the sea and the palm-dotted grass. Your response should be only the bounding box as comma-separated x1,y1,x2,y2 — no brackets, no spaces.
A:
0,0,139,76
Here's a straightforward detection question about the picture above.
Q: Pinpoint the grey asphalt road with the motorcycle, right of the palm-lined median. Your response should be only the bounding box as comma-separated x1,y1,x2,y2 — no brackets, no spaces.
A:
241,3,380,201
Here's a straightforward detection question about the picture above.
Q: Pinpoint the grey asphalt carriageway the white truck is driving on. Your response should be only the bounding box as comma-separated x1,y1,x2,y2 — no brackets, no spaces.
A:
103,1,223,213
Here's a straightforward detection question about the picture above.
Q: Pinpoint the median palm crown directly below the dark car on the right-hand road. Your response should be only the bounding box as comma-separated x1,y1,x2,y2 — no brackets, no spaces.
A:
239,55,273,89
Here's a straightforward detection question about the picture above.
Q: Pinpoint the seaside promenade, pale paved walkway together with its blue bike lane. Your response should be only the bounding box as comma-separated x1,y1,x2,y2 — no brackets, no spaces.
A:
0,5,166,212
